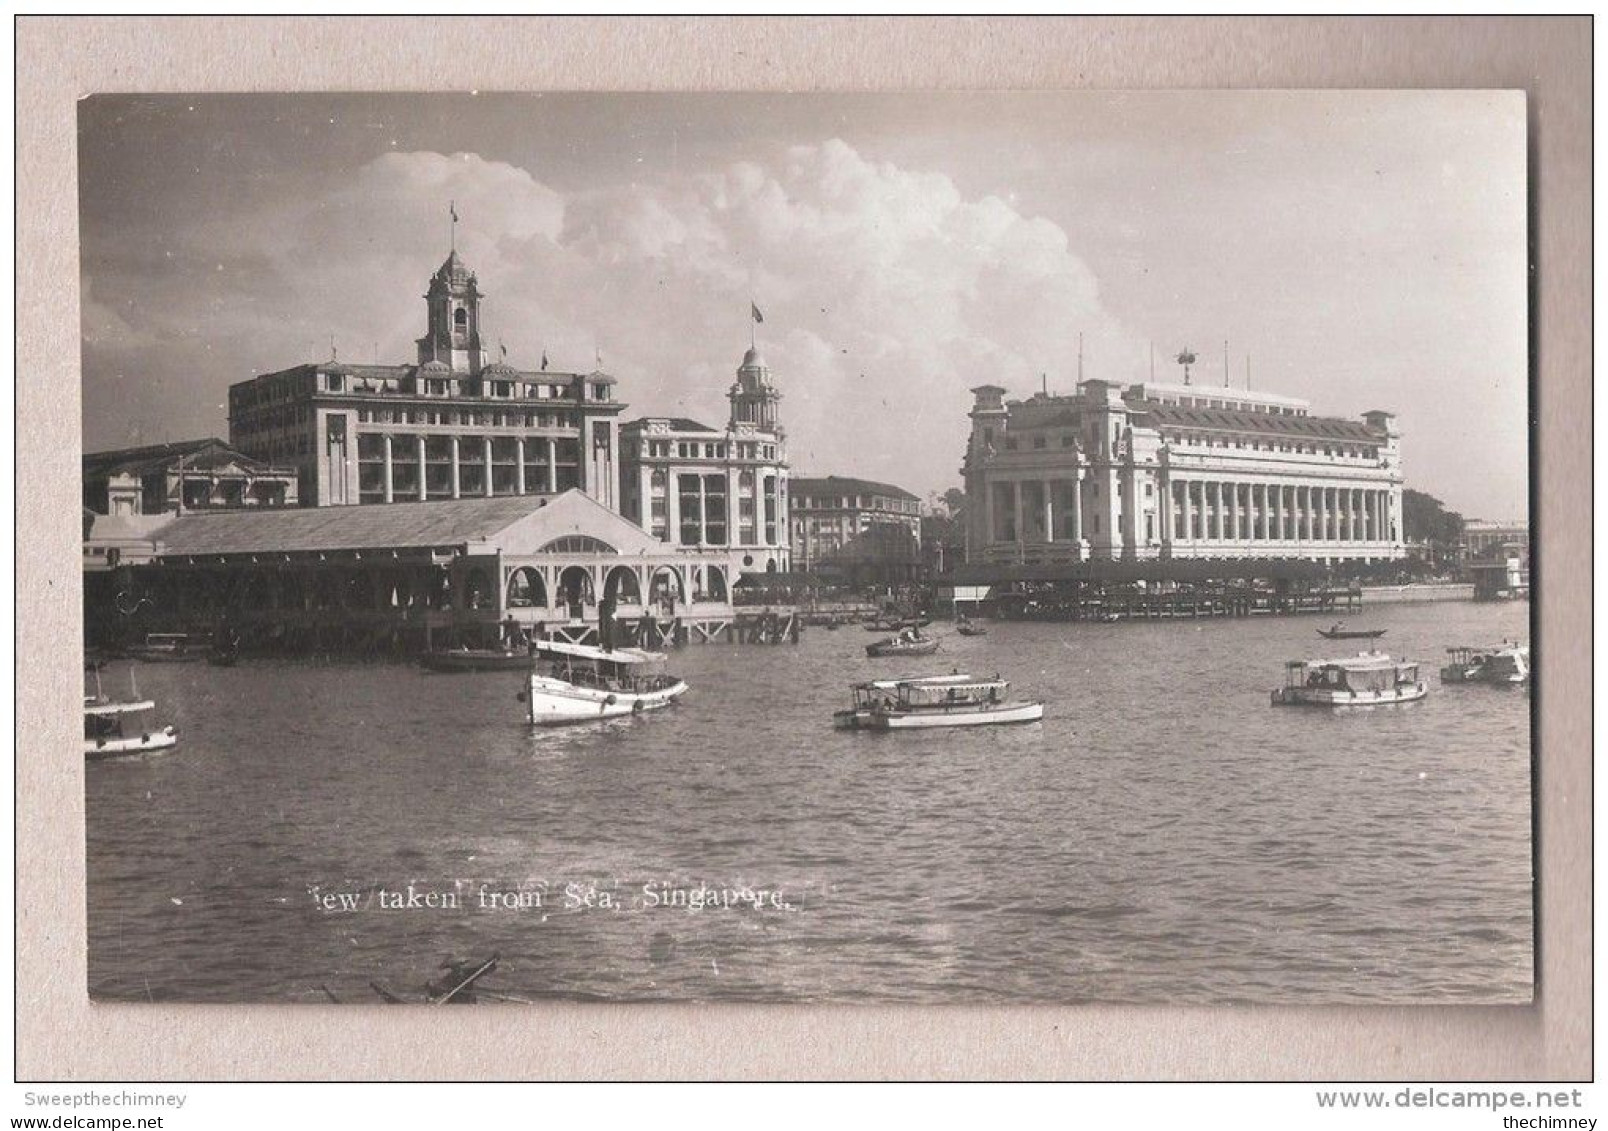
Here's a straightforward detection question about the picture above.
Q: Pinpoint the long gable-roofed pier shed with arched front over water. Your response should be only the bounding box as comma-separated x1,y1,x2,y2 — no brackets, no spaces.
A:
85,489,746,652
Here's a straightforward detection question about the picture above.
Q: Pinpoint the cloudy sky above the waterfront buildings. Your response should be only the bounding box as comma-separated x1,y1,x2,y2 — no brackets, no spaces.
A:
79,92,1528,518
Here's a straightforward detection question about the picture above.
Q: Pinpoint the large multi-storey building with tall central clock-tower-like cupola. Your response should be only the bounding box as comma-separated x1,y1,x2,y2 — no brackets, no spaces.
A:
228,251,624,510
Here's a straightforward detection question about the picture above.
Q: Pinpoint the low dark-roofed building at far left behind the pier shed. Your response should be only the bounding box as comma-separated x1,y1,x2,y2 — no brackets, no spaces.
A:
82,439,297,516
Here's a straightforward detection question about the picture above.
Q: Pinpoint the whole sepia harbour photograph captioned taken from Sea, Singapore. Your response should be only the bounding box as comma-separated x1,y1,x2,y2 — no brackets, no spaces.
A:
78,90,1539,1006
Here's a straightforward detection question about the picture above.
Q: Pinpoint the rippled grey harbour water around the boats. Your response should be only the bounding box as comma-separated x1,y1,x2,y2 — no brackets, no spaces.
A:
85,602,1545,1004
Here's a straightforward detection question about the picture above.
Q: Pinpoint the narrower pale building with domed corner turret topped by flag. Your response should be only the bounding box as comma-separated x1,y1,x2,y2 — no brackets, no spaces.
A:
621,349,790,576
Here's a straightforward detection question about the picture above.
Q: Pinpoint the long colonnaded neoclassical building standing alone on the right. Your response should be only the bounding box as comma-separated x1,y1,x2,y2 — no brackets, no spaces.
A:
962,380,1405,563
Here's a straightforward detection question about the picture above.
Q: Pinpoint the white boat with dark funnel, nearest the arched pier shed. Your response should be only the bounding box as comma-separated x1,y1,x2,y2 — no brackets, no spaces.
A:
519,640,687,727
